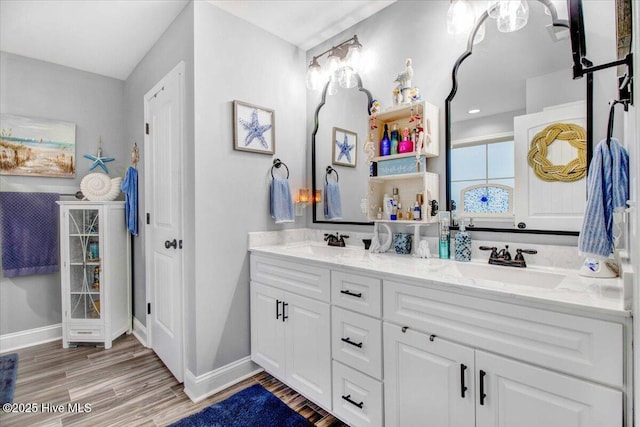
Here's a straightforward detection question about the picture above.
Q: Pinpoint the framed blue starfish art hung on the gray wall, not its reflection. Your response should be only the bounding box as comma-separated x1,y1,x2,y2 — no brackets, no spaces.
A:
233,101,276,154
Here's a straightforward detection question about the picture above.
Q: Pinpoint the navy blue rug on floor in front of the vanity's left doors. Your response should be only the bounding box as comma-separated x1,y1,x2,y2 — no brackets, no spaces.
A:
171,384,313,427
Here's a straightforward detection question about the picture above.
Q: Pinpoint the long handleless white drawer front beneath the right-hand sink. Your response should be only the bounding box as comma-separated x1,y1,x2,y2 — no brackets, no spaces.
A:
383,281,623,387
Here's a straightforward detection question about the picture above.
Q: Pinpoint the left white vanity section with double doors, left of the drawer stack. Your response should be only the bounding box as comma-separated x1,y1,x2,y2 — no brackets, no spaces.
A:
251,255,331,409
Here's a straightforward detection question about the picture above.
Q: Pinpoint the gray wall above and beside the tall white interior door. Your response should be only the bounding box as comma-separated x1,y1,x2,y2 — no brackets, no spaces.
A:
123,3,194,332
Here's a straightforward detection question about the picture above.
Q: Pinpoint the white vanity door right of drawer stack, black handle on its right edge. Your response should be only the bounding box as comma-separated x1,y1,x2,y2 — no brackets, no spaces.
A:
384,323,475,427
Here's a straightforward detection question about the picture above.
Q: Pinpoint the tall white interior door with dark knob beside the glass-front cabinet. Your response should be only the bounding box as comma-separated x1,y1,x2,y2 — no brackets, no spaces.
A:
145,63,184,382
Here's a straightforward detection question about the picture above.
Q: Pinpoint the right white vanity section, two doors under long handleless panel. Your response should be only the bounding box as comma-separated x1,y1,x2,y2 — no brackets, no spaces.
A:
383,281,623,427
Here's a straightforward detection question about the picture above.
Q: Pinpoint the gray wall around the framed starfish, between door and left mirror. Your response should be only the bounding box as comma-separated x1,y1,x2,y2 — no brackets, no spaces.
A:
191,2,307,375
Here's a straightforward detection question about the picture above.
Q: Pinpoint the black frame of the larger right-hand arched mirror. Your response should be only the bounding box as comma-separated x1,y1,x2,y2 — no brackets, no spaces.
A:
445,0,593,236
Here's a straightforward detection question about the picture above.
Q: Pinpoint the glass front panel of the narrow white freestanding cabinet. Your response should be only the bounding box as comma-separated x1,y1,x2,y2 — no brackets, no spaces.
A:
68,209,102,320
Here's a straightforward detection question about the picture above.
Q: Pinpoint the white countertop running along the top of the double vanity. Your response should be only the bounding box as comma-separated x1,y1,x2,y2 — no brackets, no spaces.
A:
249,241,631,321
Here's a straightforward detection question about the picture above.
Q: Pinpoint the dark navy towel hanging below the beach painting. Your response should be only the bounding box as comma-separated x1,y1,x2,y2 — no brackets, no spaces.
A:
0,192,60,277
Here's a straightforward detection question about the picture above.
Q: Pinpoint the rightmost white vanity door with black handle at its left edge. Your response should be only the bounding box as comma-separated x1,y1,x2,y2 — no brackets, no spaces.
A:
476,351,622,427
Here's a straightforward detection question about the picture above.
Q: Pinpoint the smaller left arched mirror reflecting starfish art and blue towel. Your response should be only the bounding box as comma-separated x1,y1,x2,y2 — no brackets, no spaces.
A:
311,76,372,224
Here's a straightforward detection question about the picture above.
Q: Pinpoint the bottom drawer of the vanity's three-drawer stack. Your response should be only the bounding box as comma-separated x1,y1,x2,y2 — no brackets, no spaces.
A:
333,361,382,427
